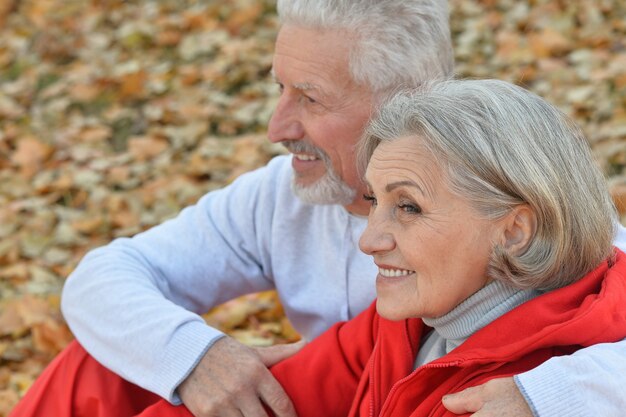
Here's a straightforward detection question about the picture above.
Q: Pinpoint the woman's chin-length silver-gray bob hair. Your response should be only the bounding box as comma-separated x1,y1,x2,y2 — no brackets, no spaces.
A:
358,80,617,290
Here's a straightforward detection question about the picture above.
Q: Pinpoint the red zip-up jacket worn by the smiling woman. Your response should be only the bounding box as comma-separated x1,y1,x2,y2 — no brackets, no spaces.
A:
272,251,626,417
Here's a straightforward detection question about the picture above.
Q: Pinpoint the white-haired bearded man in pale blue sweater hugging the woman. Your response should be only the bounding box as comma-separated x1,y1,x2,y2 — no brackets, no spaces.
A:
16,0,626,417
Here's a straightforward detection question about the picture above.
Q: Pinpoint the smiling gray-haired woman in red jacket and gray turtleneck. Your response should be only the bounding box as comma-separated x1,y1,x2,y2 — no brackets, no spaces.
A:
9,80,626,417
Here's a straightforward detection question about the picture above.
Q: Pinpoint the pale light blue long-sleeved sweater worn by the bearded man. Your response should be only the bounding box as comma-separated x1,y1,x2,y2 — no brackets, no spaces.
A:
62,156,626,417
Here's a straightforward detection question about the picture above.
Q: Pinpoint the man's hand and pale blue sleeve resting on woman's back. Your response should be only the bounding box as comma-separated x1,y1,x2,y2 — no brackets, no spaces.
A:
443,340,626,417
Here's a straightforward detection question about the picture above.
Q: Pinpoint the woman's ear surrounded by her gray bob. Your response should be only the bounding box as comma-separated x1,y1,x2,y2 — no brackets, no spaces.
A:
500,204,537,255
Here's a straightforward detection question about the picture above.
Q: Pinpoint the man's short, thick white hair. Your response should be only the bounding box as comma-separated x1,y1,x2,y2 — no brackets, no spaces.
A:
277,0,454,93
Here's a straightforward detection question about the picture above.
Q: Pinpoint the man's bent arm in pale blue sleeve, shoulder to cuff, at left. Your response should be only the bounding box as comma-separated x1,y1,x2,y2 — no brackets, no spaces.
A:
62,157,286,402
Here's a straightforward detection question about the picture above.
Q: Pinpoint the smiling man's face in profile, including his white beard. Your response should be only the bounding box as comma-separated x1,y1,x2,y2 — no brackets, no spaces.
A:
268,25,372,214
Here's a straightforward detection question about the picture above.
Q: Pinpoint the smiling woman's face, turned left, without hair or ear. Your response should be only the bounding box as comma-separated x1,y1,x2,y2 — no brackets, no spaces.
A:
360,137,501,320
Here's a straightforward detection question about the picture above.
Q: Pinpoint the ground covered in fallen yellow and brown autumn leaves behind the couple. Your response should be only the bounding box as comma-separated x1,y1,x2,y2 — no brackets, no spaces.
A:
0,0,626,410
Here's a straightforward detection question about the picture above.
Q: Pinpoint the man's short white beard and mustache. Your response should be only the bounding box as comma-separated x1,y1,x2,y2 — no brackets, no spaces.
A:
284,140,356,206
